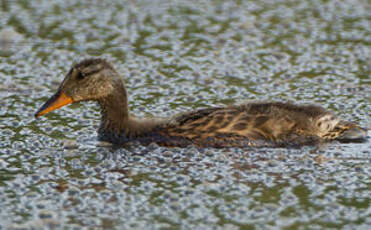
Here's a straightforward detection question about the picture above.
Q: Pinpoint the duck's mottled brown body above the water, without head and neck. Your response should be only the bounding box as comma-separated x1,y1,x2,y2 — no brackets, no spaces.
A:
98,102,362,148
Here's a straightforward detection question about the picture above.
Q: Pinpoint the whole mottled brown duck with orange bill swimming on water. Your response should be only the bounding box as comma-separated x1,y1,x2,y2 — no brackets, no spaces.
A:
35,59,367,147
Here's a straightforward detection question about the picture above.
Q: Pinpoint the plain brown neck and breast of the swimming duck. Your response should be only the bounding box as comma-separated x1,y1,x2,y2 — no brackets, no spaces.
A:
98,89,159,142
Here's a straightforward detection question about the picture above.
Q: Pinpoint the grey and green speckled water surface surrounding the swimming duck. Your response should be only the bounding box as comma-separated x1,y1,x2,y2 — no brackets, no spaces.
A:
0,0,371,229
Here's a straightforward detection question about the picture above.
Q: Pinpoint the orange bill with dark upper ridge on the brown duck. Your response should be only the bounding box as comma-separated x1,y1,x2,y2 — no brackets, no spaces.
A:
35,90,73,118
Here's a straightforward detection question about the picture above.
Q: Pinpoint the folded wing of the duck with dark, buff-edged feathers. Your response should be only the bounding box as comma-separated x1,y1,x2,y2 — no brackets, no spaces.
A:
165,103,318,147
